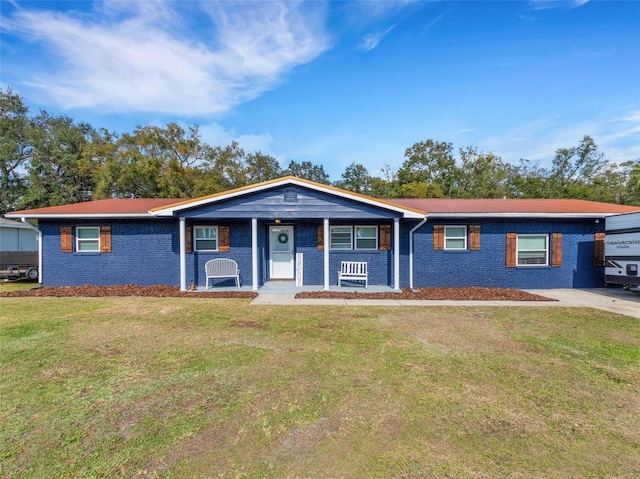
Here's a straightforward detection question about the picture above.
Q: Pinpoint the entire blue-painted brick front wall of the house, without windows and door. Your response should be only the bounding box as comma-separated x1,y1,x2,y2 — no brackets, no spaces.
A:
39,219,604,289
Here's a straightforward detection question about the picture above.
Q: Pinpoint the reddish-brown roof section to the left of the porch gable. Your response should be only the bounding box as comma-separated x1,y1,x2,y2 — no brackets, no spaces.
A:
7,198,181,218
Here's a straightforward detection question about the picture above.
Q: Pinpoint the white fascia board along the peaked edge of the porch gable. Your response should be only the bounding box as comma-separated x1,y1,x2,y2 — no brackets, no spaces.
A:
150,179,424,219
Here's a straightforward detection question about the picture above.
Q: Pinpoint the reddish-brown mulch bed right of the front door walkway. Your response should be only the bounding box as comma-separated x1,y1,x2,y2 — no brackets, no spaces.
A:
296,287,556,301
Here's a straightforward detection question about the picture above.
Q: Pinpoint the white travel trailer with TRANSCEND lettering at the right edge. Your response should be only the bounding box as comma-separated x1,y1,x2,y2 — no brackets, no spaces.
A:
604,213,640,289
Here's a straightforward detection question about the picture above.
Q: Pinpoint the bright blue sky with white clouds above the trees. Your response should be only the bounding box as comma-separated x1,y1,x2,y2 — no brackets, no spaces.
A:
0,0,640,180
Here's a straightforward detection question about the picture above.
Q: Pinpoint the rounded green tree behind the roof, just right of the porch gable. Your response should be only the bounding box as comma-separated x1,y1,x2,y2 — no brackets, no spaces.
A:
398,140,459,197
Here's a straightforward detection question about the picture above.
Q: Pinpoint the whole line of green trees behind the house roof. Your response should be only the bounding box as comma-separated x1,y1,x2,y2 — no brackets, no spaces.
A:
0,87,640,214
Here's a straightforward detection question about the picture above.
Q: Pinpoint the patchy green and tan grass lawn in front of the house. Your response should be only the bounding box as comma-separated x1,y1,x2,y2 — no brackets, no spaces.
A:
0,298,640,478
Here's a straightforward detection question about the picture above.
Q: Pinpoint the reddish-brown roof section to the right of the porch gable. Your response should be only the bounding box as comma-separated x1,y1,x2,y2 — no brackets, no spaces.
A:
392,198,640,215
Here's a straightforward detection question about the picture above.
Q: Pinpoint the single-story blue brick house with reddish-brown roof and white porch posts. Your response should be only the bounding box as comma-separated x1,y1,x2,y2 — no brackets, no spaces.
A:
6,176,640,290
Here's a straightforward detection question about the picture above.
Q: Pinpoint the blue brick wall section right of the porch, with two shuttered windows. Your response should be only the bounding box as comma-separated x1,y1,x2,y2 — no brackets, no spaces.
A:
410,219,604,289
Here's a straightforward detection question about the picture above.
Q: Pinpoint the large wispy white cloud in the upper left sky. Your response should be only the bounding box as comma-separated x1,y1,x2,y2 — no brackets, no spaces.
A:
3,0,328,116
